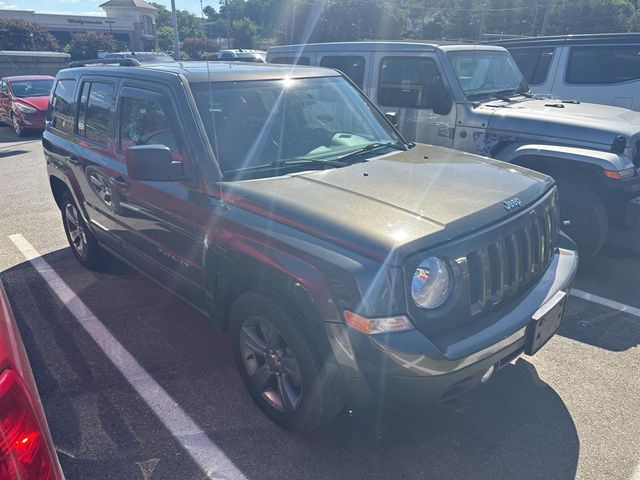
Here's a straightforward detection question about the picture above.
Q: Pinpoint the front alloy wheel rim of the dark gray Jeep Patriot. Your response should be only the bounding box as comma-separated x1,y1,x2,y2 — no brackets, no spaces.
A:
240,317,302,413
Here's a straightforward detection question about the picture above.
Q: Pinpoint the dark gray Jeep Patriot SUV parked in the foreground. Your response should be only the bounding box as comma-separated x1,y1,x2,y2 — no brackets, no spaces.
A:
43,60,577,430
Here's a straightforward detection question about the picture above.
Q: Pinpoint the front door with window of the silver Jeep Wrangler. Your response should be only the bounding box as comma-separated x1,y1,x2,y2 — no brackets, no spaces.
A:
370,52,456,147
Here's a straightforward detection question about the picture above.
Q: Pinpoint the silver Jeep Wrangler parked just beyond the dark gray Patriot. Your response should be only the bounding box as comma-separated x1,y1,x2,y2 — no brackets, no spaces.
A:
267,42,640,260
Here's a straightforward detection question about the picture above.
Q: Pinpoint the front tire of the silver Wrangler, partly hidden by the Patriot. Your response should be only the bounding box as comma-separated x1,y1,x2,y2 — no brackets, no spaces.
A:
559,181,609,261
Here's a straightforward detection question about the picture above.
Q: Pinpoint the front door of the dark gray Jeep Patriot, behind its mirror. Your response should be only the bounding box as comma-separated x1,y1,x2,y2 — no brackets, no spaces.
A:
110,83,208,305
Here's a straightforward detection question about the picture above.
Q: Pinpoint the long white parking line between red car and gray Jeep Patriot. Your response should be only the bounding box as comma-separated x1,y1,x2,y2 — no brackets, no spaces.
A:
9,234,245,479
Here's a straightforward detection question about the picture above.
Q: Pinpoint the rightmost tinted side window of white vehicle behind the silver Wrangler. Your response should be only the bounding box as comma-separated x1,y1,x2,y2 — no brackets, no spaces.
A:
566,45,640,85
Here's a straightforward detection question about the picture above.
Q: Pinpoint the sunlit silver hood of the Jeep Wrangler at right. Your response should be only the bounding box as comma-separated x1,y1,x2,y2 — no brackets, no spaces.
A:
478,99,640,149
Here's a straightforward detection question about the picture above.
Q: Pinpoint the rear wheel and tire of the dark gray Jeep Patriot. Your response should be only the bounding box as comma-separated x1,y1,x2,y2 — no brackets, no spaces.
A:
60,192,109,270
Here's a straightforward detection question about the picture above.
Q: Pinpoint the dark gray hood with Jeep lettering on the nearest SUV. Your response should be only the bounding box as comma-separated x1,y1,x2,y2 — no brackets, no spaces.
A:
224,145,553,263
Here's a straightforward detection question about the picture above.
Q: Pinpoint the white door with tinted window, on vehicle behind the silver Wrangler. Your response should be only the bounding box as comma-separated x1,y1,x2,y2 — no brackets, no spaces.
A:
552,44,640,110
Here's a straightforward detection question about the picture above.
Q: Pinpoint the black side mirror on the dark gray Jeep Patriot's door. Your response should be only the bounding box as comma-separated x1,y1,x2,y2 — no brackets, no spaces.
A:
125,145,185,182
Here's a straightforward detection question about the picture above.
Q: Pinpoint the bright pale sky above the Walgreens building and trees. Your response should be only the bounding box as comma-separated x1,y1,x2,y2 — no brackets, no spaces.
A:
0,0,218,15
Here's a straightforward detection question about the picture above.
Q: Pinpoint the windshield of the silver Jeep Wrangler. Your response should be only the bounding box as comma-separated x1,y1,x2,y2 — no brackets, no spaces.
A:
448,50,529,99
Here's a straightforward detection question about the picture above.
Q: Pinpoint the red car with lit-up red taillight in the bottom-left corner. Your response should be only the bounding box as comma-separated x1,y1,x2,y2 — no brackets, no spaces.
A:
0,281,64,480
